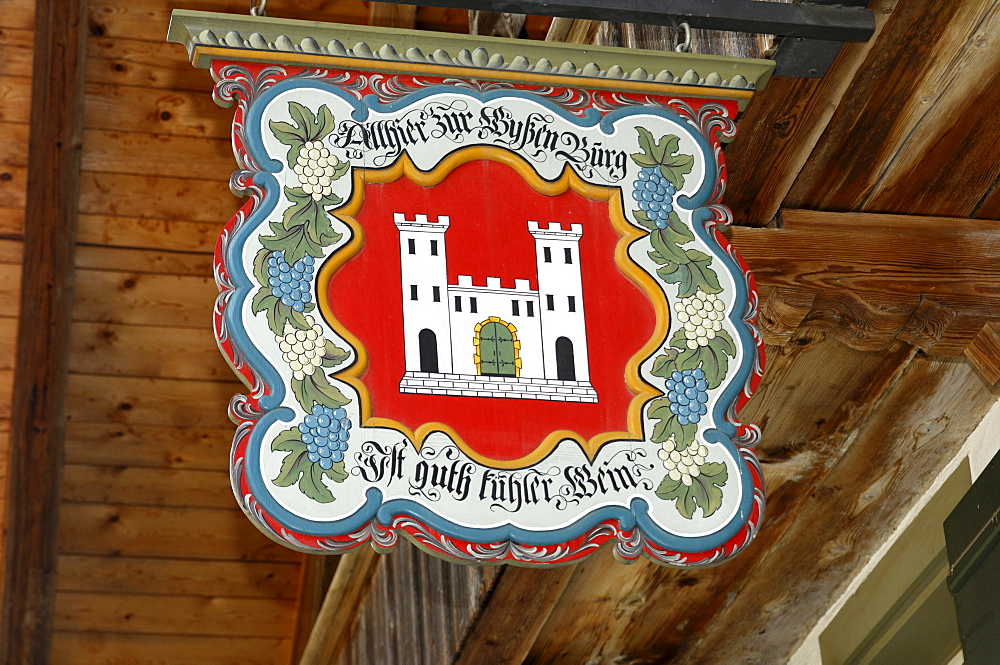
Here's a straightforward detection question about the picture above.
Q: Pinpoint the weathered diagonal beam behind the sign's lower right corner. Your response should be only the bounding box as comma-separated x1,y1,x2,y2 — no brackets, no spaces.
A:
526,338,913,665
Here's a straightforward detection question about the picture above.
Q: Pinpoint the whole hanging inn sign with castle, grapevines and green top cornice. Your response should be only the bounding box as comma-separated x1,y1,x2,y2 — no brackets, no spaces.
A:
170,11,773,566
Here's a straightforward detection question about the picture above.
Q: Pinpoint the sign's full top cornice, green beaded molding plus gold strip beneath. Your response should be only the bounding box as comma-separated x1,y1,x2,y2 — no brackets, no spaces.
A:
167,10,774,109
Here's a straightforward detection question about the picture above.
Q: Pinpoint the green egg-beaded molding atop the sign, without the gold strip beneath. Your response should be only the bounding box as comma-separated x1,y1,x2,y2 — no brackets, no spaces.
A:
167,9,774,96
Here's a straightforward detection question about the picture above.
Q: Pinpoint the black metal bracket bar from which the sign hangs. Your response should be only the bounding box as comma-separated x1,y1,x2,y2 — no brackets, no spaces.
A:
364,0,875,78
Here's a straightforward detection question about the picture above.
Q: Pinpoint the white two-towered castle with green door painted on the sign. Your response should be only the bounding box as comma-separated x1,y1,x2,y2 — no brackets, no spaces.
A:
393,212,597,402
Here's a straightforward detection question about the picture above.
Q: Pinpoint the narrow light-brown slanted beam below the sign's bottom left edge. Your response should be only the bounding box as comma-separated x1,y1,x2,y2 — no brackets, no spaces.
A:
299,545,382,665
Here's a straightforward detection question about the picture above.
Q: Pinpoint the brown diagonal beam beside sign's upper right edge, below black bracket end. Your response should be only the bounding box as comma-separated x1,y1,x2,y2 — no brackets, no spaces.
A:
726,0,907,226
